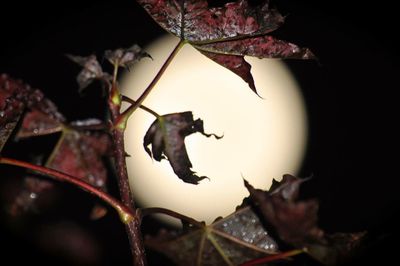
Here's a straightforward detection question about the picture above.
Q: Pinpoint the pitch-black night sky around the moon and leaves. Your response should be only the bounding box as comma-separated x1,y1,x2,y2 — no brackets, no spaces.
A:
0,0,400,265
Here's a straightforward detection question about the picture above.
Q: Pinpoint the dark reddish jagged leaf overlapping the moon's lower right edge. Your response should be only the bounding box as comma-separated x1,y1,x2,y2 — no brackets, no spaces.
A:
244,175,365,265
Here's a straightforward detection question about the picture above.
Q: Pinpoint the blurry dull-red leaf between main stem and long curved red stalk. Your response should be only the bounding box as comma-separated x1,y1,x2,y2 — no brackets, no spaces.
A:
46,129,111,190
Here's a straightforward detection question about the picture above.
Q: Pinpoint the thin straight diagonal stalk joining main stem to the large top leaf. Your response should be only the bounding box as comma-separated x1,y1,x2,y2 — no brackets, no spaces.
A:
115,40,186,128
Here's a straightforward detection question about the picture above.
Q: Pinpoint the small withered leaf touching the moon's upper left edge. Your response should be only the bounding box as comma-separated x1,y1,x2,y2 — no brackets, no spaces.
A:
104,44,151,69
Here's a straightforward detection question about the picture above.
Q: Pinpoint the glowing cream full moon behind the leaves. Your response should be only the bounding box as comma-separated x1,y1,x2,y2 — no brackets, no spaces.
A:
121,36,307,223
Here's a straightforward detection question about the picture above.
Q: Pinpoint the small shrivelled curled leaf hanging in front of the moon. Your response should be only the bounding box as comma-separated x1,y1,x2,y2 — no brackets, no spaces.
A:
143,112,221,184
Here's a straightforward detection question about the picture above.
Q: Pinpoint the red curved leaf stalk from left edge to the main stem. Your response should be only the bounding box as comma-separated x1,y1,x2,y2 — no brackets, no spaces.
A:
0,157,137,224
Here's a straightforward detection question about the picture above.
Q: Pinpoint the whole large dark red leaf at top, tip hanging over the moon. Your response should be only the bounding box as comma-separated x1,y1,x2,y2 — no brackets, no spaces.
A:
138,0,315,93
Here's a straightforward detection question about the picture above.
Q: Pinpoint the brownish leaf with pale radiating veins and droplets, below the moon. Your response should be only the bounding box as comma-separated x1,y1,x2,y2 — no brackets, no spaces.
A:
145,207,278,265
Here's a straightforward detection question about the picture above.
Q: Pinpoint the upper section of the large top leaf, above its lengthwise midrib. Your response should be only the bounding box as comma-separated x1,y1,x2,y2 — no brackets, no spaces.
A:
138,0,283,44
